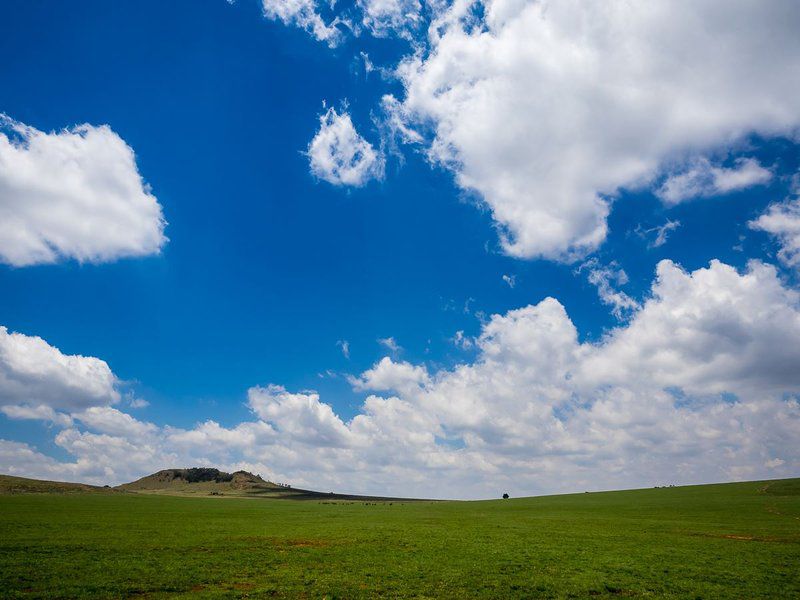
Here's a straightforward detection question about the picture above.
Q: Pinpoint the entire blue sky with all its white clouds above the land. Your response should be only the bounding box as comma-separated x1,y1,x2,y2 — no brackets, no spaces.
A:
0,0,800,498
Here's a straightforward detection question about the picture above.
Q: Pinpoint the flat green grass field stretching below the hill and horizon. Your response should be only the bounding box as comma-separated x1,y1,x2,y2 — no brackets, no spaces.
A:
0,480,800,599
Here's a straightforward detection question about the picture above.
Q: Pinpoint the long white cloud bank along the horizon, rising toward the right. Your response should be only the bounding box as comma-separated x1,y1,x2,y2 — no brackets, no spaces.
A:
0,261,800,497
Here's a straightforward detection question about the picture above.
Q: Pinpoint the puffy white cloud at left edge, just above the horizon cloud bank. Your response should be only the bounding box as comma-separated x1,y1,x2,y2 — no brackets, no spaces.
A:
0,326,120,418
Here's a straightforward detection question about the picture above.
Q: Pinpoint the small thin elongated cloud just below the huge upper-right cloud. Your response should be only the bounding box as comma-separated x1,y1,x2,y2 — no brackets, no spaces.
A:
656,158,772,205
